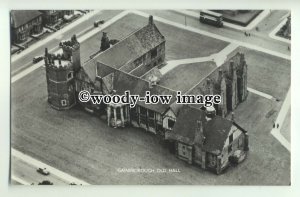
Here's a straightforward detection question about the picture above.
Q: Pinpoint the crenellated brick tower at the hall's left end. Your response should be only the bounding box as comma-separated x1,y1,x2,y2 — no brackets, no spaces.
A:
44,48,76,110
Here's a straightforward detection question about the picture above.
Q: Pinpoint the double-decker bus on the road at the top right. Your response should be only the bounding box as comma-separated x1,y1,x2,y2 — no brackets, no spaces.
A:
199,10,223,27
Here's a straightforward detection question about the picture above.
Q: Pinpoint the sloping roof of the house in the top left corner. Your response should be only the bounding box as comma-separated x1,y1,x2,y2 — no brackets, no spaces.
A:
10,10,42,28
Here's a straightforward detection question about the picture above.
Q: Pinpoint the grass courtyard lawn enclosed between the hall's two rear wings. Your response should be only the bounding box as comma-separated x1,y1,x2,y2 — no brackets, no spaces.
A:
159,62,216,92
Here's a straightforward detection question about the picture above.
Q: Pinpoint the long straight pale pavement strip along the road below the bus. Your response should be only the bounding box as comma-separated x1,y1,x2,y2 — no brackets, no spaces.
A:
131,10,291,60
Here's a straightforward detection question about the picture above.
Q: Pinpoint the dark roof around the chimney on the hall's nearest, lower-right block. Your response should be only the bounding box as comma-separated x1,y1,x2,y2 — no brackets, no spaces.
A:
167,105,233,153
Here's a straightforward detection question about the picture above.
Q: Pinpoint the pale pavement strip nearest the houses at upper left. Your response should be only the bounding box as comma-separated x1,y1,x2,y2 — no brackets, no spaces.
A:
11,10,101,62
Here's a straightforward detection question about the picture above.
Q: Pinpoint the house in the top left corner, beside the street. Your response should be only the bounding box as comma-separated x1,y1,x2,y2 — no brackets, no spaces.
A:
10,10,43,44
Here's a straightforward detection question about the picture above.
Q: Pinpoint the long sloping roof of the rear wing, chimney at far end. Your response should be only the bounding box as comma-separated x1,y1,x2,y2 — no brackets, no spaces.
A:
94,17,165,68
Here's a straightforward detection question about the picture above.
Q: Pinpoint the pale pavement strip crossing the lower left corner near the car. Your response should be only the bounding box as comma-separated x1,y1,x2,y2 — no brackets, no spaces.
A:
11,148,90,185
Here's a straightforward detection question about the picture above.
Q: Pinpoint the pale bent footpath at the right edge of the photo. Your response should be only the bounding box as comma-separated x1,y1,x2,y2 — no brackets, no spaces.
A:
271,88,291,152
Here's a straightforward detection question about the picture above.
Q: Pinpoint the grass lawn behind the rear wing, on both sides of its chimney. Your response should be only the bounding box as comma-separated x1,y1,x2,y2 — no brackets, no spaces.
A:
81,14,229,63
